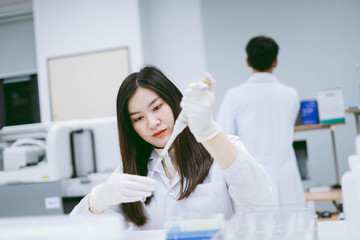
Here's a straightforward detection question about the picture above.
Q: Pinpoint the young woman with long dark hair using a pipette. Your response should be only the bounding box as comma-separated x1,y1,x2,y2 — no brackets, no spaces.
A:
71,67,271,229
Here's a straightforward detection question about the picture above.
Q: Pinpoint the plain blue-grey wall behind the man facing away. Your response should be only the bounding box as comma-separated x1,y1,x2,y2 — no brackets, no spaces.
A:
201,0,360,210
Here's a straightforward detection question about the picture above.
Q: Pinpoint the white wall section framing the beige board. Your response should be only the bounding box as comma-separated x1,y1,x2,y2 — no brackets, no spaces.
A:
33,0,143,122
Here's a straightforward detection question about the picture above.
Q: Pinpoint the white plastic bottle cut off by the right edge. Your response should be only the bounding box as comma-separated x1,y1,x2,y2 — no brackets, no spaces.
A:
341,155,360,240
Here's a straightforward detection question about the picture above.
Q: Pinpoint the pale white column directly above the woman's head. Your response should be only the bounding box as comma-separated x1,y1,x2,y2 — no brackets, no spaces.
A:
139,0,206,91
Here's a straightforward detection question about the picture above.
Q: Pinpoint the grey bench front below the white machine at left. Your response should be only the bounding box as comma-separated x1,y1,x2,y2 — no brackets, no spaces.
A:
0,173,111,217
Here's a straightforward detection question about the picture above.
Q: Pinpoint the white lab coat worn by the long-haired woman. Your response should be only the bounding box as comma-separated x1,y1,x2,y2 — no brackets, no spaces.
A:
70,136,272,230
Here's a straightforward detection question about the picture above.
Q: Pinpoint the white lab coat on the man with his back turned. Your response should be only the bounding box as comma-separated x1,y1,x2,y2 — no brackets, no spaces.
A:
217,73,305,205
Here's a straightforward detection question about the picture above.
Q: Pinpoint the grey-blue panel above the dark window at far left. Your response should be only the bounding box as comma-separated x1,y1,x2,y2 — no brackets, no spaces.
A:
0,15,36,75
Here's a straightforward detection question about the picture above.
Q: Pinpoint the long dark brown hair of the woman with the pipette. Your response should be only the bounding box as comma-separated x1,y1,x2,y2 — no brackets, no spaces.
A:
116,66,213,226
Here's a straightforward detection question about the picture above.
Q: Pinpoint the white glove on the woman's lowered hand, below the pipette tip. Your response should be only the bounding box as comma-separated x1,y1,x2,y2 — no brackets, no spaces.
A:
89,173,155,212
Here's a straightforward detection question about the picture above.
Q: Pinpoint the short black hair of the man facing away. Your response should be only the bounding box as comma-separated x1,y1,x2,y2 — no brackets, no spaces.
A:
246,36,279,71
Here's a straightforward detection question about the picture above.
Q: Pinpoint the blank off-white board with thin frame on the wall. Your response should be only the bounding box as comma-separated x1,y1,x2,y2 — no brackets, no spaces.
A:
48,48,129,121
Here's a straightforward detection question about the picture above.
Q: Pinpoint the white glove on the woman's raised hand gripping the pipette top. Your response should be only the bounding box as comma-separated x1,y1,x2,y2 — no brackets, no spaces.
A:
180,73,221,142
